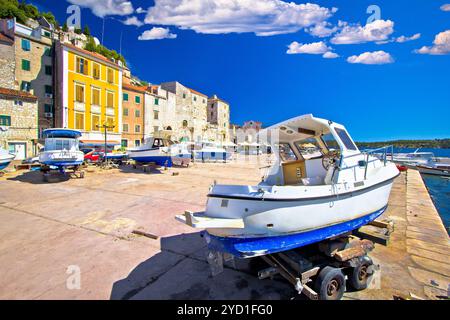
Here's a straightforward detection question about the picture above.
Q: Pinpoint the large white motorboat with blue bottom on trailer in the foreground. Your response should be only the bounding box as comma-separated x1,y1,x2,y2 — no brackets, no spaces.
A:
176,115,400,258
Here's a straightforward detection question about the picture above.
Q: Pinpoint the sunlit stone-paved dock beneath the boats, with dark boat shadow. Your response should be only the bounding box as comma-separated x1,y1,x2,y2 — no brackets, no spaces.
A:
0,161,450,300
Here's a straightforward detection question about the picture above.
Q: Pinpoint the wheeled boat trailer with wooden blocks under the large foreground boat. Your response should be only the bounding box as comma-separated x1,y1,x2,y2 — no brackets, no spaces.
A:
207,221,393,300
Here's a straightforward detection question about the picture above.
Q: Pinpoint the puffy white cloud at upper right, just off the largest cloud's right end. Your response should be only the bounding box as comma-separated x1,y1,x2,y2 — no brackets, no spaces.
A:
331,20,394,44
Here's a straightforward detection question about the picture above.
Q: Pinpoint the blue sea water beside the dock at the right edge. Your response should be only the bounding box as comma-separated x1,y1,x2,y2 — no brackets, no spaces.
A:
394,148,450,234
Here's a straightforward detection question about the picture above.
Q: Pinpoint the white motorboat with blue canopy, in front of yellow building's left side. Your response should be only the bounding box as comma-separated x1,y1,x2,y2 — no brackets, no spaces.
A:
39,129,84,170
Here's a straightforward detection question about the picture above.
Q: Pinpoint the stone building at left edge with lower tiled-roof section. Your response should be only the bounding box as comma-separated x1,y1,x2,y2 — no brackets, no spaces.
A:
0,24,38,160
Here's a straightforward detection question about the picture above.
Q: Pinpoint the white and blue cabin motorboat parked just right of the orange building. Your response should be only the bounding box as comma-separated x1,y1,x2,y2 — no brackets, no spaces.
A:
128,136,191,167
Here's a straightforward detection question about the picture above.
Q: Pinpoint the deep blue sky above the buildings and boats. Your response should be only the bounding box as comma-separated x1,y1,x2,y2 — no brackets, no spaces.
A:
31,0,450,141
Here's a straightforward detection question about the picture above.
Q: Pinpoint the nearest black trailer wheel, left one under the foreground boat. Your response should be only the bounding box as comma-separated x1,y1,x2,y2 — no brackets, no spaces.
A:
315,266,345,300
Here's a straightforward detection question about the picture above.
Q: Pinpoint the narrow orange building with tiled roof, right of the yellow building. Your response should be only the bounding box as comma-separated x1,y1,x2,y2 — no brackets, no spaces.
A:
122,82,147,148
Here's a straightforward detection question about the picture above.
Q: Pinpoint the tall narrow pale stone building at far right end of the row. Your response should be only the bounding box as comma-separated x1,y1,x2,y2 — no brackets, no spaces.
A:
207,95,230,143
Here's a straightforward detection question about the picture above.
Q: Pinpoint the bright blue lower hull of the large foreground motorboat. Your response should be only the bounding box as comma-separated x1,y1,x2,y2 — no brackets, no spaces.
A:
204,206,387,258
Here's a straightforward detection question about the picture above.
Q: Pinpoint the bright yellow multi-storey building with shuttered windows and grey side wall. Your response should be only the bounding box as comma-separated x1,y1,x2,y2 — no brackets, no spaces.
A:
55,42,123,146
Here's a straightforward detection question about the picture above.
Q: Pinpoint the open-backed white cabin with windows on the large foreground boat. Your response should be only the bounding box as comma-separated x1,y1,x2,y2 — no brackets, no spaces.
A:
260,115,360,185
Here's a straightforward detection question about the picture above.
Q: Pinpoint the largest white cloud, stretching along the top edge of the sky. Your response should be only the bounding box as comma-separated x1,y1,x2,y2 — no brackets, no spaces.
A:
145,0,337,36
